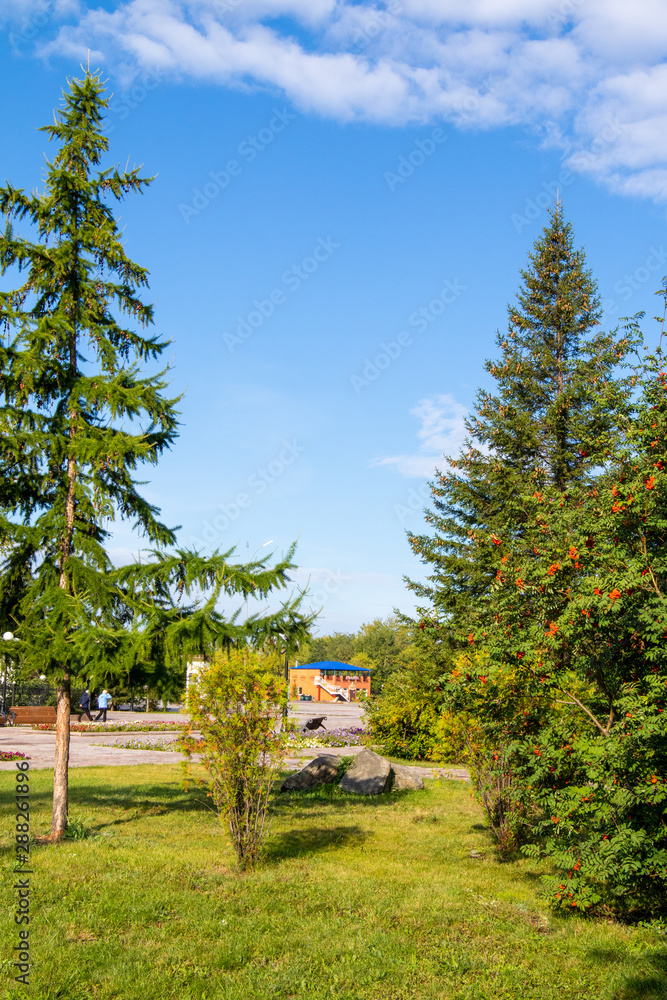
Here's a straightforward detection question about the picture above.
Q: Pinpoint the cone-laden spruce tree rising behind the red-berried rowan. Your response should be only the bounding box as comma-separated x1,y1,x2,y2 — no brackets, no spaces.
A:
408,205,631,648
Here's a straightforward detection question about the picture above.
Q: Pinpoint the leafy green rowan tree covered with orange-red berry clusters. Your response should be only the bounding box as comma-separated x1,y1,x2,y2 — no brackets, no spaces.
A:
444,327,667,913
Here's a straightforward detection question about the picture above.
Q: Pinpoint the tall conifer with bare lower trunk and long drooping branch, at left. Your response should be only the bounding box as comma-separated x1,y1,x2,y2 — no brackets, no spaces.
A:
0,71,308,840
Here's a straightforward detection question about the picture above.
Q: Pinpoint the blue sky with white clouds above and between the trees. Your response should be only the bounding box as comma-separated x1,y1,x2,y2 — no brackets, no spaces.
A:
0,0,667,632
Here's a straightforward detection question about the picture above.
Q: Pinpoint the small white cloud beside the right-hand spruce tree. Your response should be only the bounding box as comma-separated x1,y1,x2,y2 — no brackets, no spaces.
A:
371,395,468,478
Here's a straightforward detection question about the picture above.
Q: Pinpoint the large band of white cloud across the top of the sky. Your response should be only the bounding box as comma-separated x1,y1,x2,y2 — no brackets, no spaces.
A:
30,0,667,200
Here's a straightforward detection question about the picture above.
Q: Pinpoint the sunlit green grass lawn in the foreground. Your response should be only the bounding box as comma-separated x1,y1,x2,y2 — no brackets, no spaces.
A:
0,764,667,1000
